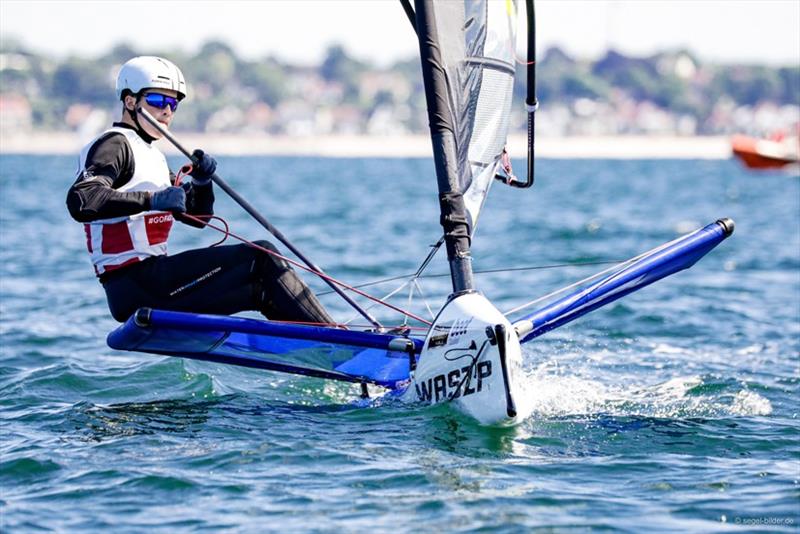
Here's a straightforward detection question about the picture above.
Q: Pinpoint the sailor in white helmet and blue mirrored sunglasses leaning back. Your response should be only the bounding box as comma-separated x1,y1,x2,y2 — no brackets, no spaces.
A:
67,56,332,323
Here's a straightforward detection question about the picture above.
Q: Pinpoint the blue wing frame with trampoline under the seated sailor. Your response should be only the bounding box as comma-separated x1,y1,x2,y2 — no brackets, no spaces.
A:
107,308,423,388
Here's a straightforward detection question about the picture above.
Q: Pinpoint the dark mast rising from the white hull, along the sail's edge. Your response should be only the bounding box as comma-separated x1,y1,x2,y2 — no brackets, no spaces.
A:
416,0,473,293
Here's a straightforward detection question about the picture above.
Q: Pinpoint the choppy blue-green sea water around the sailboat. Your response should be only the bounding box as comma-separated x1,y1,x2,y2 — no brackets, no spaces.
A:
0,156,800,532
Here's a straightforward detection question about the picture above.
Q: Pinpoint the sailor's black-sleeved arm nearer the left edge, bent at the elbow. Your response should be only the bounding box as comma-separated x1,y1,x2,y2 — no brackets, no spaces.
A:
67,134,150,223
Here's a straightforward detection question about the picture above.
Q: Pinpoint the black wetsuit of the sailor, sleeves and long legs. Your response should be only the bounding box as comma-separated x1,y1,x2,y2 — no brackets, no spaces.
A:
67,123,332,323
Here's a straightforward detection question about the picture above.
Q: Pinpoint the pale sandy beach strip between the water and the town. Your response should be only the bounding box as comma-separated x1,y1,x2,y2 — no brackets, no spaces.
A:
0,132,731,159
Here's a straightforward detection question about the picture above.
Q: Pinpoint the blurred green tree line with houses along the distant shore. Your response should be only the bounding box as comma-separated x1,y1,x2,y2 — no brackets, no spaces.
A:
0,40,800,135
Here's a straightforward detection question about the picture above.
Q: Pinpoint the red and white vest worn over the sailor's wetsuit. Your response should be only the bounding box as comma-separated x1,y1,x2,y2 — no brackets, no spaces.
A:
78,128,173,276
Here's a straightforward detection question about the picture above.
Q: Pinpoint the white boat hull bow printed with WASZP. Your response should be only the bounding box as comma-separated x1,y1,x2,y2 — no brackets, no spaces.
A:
402,293,524,425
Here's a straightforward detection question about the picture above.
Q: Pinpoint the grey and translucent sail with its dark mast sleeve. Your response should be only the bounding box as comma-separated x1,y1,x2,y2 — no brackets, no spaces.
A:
416,0,516,292
